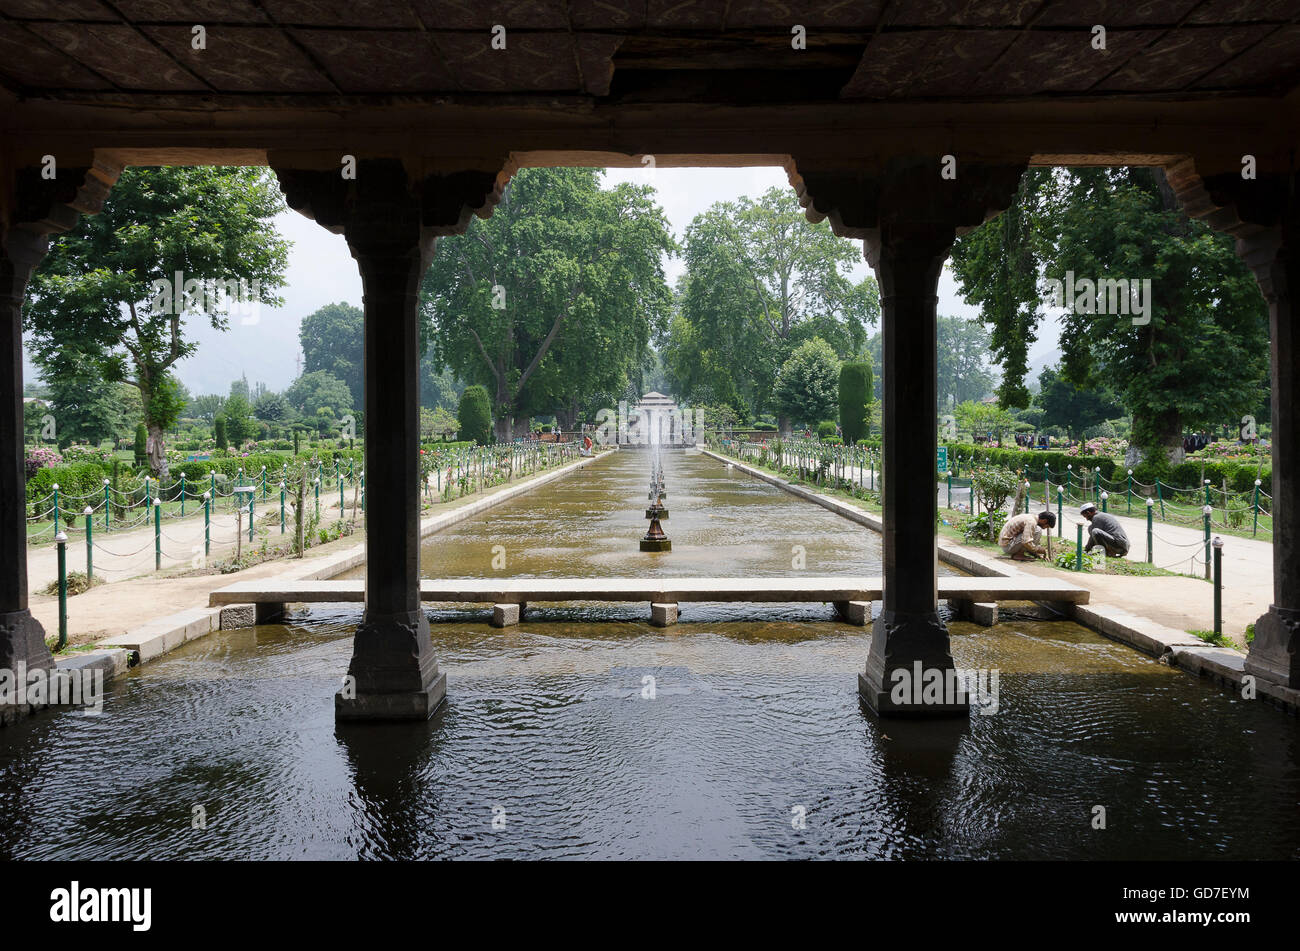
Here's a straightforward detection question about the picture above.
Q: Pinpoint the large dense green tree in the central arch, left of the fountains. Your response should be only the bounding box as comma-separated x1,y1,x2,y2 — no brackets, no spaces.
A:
421,169,676,439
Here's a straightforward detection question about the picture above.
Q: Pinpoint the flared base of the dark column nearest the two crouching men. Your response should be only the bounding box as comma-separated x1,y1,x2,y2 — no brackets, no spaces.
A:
858,611,970,717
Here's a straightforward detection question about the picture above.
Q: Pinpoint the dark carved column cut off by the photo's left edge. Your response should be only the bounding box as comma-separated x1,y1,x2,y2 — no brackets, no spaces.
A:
0,159,121,722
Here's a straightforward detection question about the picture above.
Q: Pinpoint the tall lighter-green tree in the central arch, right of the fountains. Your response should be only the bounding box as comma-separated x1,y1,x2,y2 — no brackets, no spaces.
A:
663,188,880,431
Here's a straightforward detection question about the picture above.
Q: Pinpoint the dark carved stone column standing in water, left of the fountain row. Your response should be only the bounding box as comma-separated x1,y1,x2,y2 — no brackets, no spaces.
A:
273,159,499,720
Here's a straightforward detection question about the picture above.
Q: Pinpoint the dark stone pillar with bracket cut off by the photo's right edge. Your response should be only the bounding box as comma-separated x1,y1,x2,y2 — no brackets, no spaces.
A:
1166,156,1300,690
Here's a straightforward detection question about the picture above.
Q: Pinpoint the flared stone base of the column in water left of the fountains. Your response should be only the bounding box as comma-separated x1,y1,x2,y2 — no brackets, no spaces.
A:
334,611,447,721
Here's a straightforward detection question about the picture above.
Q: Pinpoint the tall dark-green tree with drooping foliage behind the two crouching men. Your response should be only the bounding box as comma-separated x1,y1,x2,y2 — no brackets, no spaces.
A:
953,168,1269,472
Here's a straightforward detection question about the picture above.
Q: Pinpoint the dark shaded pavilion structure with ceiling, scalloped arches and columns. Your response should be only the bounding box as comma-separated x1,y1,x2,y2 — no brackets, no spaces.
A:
0,0,1300,720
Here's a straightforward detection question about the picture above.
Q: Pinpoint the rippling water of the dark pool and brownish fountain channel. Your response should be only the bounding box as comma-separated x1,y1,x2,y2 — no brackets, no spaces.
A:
0,453,1300,859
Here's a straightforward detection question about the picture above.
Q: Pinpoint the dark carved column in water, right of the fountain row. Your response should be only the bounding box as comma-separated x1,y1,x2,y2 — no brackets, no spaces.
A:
790,156,1024,716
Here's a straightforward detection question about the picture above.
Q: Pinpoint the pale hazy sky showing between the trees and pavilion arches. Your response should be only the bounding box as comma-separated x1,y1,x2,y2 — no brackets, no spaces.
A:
55,168,1054,395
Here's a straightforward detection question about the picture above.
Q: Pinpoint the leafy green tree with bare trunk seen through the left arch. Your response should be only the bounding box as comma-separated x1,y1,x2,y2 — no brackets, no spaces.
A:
23,168,289,477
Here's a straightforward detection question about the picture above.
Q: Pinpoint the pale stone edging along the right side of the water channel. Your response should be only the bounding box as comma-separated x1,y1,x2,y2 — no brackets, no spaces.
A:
701,450,1300,716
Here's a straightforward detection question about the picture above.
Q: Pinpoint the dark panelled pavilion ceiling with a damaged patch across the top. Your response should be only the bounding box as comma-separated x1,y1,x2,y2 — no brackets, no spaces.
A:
0,0,1300,107
